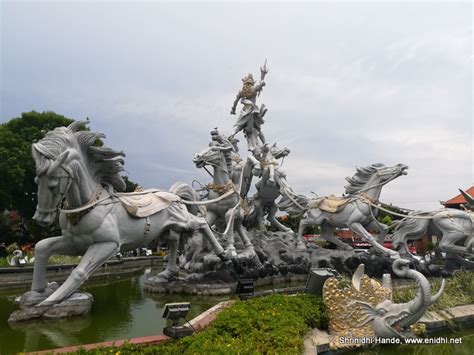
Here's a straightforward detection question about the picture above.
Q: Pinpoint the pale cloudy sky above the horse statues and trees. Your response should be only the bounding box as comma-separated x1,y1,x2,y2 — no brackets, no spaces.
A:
0,0,474,209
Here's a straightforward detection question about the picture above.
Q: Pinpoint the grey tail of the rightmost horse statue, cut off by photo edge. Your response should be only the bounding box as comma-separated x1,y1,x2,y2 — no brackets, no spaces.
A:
393,216,431,253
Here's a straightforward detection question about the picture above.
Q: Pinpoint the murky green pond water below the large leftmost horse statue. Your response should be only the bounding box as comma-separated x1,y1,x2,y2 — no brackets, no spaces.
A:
0,267,231,354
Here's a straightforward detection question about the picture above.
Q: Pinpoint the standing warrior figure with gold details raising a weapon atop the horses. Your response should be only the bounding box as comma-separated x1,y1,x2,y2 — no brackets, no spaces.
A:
229,60,268,149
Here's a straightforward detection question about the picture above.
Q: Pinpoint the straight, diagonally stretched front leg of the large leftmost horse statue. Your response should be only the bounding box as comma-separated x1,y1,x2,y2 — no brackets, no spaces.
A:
39,242,120,306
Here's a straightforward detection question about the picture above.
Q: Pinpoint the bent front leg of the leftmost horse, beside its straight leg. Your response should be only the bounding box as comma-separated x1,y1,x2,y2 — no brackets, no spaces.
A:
31,236,83,292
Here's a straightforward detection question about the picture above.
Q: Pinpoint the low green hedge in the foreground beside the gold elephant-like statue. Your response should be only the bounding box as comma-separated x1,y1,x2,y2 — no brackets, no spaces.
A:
79,294,328,354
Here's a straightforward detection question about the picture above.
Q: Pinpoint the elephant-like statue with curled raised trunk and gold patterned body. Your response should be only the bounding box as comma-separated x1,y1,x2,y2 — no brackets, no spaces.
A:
323,259,445,349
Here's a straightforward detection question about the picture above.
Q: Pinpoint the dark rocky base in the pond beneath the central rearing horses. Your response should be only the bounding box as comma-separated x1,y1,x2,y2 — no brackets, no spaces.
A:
144,231,311,295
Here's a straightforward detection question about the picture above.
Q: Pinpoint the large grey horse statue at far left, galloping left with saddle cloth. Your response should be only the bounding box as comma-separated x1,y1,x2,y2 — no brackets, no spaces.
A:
27,121,224,306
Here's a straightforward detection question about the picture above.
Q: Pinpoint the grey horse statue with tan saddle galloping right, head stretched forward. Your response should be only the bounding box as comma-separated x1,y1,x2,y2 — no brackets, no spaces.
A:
278,164,408,258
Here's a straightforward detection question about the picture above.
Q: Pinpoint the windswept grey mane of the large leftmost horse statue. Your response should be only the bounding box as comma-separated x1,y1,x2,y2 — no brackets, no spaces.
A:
32,121,125,191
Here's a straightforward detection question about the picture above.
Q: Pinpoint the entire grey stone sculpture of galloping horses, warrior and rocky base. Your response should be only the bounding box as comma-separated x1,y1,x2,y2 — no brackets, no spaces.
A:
9,63,474,328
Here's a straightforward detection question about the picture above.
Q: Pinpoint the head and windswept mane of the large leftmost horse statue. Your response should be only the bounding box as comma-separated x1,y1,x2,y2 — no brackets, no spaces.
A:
32,121,125,226
